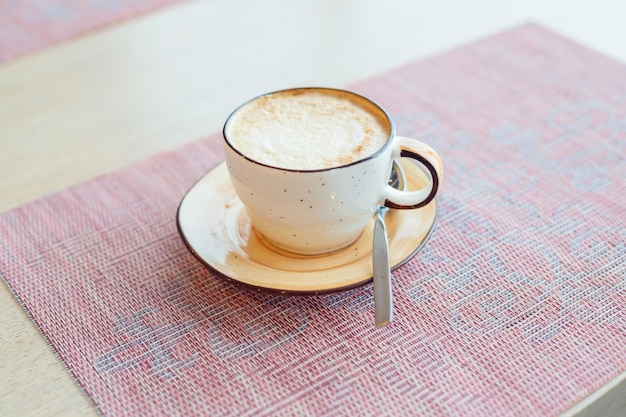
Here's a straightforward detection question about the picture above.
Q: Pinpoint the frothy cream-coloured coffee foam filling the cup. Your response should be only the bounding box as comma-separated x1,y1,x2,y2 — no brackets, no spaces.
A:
224,88,391,170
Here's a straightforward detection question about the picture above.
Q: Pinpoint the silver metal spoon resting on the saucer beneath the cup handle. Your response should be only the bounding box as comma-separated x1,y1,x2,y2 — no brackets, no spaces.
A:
372,161,404,327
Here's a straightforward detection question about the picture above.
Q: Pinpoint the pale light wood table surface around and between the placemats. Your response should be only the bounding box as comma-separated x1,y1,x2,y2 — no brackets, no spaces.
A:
0,0,626,416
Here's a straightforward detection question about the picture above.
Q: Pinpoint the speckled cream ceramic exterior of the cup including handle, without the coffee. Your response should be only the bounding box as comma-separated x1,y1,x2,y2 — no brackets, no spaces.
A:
223,87,442,255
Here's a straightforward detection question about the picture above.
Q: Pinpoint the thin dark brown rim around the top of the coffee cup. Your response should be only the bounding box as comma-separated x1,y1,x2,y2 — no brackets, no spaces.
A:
222,87,396,172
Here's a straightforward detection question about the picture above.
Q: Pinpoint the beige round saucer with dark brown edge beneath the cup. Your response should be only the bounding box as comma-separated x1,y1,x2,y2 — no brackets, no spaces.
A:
177,161,437,294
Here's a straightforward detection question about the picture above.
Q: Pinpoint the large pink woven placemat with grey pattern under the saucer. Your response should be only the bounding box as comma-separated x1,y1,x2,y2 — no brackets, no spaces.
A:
0,25,626,416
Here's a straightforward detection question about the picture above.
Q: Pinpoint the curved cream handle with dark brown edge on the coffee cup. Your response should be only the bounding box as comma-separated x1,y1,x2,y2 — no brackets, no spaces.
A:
384,136,443,209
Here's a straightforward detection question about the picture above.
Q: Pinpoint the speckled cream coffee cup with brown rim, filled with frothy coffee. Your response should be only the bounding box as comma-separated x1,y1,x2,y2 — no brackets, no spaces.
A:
223,87,443,255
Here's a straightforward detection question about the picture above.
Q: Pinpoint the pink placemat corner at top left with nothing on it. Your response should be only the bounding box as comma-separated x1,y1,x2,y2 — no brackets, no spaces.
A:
0,0,183,64
